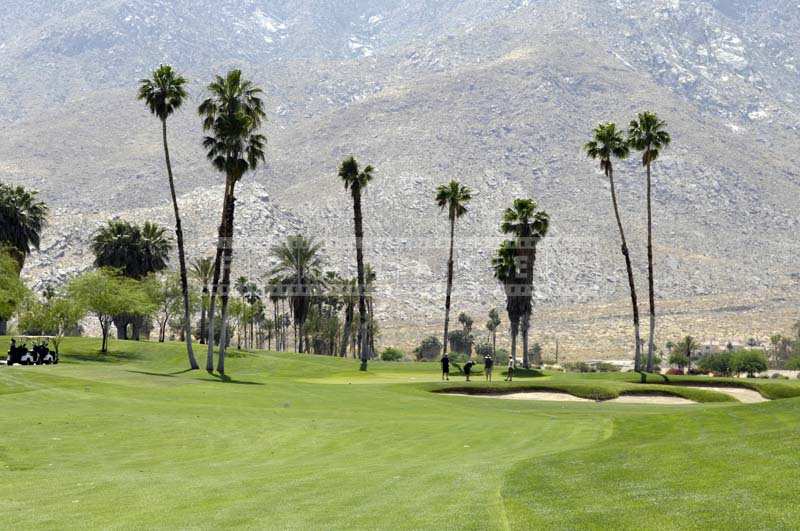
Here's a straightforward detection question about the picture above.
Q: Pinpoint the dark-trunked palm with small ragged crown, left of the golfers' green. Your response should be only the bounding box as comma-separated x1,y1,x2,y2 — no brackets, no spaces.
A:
339,157,375,371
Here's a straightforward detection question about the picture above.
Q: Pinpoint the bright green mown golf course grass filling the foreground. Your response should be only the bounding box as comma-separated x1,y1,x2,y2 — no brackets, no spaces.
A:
0,338,800,529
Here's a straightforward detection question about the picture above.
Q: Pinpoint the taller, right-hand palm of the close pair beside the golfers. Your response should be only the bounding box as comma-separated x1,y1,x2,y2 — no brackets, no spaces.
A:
500,199,550,369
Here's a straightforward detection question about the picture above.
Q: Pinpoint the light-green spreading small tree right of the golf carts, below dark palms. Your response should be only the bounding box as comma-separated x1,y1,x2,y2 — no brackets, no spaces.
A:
67,269,155,354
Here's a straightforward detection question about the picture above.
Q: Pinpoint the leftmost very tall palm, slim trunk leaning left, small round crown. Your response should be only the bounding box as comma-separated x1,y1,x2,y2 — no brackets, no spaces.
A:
138,65,195,370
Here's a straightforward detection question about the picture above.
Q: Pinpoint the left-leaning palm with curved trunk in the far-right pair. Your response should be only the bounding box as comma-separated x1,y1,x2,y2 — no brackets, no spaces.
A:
583,123,642,372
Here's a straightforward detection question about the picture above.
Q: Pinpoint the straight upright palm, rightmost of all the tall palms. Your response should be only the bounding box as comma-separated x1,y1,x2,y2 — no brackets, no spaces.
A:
628,112,672,372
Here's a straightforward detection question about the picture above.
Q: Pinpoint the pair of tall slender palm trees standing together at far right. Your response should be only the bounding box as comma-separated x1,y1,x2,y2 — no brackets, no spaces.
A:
584,112,671,372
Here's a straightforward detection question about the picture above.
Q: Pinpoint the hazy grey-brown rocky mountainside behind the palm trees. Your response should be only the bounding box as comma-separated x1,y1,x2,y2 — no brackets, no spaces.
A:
0,0,800,354
